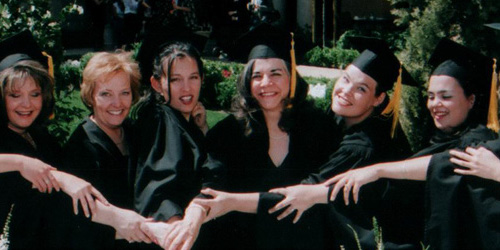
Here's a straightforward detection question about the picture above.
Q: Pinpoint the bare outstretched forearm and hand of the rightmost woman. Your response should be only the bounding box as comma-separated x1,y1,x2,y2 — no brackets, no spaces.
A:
324,155,432,205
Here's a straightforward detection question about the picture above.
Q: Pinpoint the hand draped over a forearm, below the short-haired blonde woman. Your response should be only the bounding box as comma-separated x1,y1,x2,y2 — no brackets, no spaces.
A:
53,171,109,217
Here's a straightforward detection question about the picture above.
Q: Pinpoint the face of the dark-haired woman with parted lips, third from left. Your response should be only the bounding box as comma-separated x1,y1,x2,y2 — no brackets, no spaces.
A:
151,56,202,120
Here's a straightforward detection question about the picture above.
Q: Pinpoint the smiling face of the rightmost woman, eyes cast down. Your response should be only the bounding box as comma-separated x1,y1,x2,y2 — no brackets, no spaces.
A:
427,75,475,132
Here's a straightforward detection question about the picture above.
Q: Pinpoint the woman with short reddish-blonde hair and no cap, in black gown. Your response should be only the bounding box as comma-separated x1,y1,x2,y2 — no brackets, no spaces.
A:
63,52,151,248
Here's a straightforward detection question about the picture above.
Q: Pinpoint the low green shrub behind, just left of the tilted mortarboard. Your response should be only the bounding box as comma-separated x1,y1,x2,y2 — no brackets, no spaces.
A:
305,47,359,68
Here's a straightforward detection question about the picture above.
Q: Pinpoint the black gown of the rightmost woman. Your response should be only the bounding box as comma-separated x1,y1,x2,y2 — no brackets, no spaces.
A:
425,125,500,249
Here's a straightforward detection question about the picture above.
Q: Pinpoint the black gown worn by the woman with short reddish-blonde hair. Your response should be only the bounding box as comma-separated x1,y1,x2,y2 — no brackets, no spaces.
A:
56,117,135,249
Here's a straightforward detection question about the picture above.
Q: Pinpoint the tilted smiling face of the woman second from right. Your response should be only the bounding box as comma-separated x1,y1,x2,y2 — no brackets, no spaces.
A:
332,65,385,126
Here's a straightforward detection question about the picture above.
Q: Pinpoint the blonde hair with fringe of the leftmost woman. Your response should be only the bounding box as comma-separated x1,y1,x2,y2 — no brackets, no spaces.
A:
0,60,55,124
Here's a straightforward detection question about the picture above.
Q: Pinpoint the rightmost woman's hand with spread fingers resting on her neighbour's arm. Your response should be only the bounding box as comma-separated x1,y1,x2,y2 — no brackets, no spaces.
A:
323,167,379,205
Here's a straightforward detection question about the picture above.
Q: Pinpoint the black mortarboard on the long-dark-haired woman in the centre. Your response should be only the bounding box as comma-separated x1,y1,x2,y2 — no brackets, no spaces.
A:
233,23,292,63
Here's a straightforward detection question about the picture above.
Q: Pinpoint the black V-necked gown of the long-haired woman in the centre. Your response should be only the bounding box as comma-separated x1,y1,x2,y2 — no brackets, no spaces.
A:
203,107,338,249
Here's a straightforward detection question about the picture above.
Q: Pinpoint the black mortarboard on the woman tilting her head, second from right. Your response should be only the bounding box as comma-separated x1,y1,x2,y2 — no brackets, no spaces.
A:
347,37,417,92
